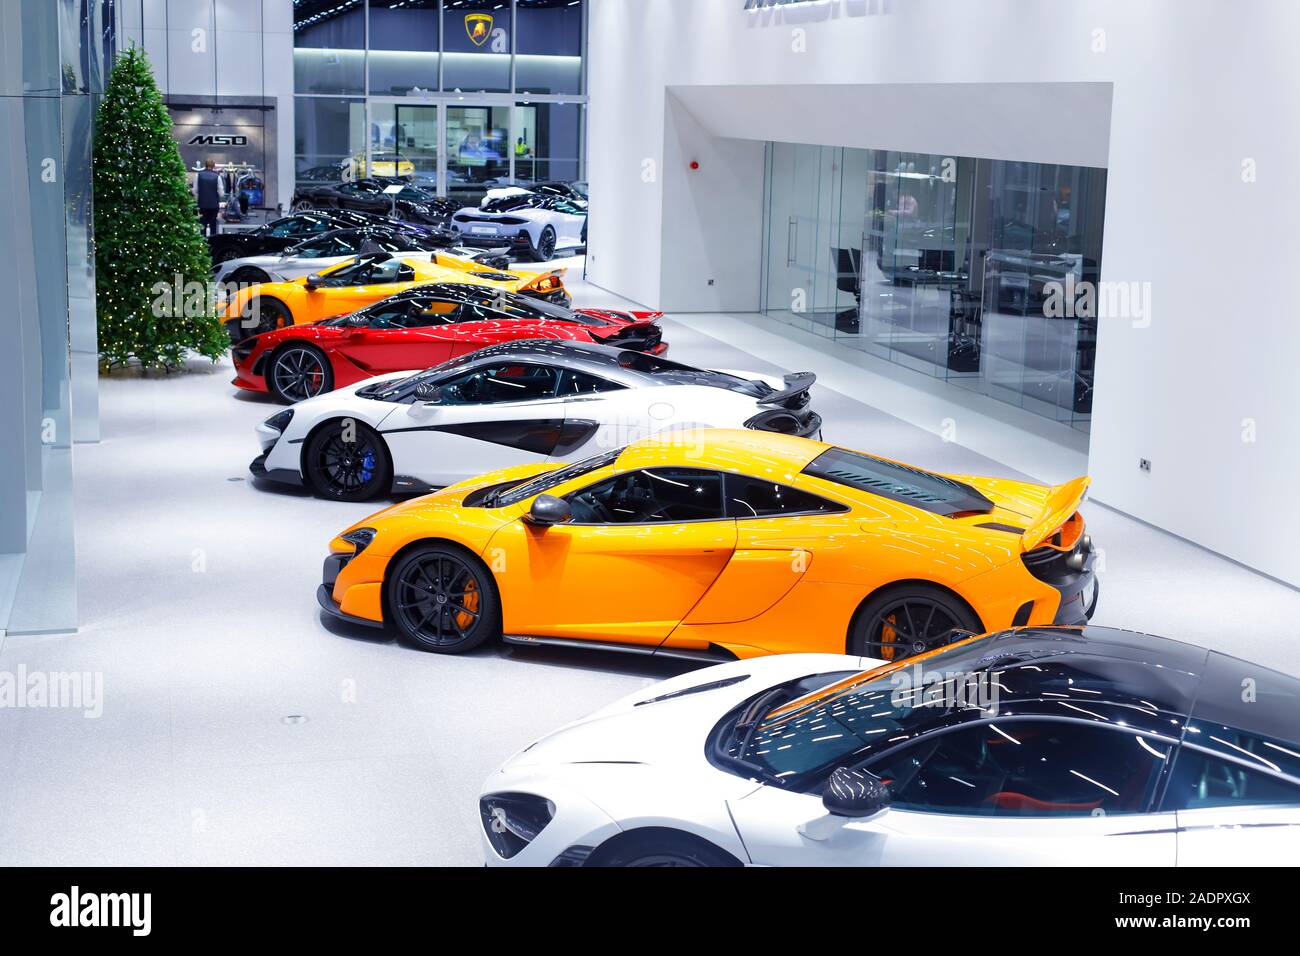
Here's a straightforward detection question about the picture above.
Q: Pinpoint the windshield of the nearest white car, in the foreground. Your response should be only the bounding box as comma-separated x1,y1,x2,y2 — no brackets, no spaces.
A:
715,635,1013,783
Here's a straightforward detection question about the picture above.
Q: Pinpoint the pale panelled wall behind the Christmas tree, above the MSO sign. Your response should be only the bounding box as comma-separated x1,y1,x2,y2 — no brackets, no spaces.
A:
117,0,294,207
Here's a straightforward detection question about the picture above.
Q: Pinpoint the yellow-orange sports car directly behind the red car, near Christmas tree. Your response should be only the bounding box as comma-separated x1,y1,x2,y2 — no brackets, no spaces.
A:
222,252,571,342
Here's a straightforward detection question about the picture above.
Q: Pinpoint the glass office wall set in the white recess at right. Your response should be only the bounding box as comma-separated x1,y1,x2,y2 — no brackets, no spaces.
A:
764,143,1106,429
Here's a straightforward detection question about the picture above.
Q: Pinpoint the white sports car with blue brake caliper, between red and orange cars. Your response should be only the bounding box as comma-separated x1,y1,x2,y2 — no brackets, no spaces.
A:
251,339,822,501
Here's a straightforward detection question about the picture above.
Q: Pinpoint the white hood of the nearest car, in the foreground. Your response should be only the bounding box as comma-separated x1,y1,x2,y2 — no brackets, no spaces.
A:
503,654,881,771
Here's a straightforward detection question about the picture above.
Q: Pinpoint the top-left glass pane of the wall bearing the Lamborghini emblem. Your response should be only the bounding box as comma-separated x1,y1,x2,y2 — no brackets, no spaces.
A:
294,0,365,94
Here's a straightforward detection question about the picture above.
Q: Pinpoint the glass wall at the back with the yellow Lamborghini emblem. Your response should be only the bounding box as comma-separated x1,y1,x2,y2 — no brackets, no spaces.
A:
294,0,586,202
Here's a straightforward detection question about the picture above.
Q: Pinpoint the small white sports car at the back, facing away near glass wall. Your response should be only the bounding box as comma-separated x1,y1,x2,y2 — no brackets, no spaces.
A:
449,186,586,263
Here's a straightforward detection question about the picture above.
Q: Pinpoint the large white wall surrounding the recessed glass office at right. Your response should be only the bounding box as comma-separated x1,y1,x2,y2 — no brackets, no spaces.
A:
588,0,1300,585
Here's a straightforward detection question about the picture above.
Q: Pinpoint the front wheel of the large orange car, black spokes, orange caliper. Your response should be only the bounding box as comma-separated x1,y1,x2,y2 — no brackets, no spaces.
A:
384,541,501,654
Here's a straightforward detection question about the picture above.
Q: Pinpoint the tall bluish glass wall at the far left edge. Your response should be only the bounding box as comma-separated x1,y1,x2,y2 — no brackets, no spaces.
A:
0,0,103,633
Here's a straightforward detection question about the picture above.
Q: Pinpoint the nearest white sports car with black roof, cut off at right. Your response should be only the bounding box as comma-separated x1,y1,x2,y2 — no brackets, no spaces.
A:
480,627,1300,866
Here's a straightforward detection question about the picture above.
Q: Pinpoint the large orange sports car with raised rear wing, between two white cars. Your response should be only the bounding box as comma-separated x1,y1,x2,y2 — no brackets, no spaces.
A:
317,429,1097,661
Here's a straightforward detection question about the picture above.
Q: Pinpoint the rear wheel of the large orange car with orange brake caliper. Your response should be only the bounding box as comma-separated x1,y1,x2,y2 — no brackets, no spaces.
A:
848,584,984,662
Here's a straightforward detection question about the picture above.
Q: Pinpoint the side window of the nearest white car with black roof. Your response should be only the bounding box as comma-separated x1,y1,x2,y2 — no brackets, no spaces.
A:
866,721,1171,817
